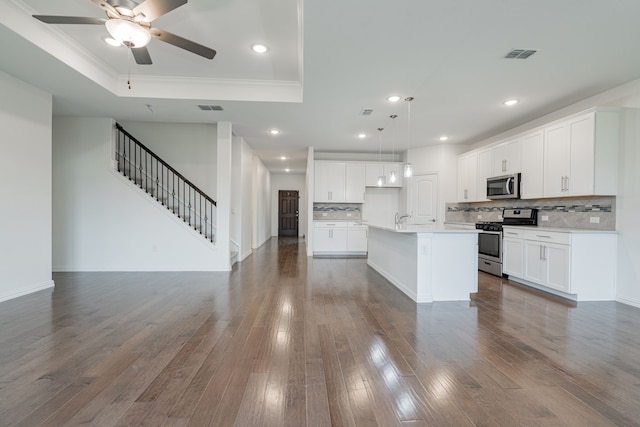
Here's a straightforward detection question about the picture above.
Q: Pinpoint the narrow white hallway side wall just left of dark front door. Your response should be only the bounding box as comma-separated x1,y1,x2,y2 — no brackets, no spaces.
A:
251,156,271,248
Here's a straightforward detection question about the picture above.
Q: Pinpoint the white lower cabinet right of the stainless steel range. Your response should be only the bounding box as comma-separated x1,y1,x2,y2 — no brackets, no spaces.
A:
503,227,617,301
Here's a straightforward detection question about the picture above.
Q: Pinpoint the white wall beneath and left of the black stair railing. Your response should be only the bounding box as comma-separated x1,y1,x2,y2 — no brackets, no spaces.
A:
53,117,229,271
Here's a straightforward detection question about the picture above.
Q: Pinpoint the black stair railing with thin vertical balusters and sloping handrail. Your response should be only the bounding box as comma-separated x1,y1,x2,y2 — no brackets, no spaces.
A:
115,123,216,243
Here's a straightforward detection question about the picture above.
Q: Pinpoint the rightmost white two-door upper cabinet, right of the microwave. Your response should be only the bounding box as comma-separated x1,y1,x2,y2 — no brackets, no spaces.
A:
543,111,620,197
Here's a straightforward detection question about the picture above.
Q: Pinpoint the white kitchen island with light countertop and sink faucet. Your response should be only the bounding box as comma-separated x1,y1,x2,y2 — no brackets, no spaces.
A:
367,224,478,303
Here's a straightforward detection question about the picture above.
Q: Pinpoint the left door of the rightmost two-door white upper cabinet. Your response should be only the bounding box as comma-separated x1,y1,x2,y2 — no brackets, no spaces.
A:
543,123,569,197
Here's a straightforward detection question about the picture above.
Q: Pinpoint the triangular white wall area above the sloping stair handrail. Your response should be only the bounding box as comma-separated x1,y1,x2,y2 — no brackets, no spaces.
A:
119,121,218,200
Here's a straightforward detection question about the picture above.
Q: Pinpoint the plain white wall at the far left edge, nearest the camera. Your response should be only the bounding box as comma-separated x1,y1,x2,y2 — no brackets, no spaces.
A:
0,71,53,301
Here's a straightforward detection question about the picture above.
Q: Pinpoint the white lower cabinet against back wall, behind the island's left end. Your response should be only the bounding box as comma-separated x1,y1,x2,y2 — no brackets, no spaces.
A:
313,221,367,254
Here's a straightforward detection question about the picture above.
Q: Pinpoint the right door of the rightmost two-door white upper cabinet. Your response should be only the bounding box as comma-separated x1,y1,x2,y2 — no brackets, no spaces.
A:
566,113,595,196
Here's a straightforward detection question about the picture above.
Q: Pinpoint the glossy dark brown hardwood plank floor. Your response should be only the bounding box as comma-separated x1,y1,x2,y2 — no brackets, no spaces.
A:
0,238,640,427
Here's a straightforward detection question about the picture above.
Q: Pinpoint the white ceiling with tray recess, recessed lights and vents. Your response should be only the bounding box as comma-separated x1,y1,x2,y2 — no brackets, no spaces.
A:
0,0,640,173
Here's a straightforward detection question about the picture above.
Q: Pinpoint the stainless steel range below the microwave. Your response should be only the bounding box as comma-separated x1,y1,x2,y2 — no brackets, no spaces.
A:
476,209,538,276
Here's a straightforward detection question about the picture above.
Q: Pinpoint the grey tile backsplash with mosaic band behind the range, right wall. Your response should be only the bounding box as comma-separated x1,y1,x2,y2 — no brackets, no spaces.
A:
445,196,616,230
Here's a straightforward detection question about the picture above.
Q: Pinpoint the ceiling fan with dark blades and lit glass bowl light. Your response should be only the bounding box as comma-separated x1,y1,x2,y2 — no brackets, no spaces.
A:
33,0,216,65
